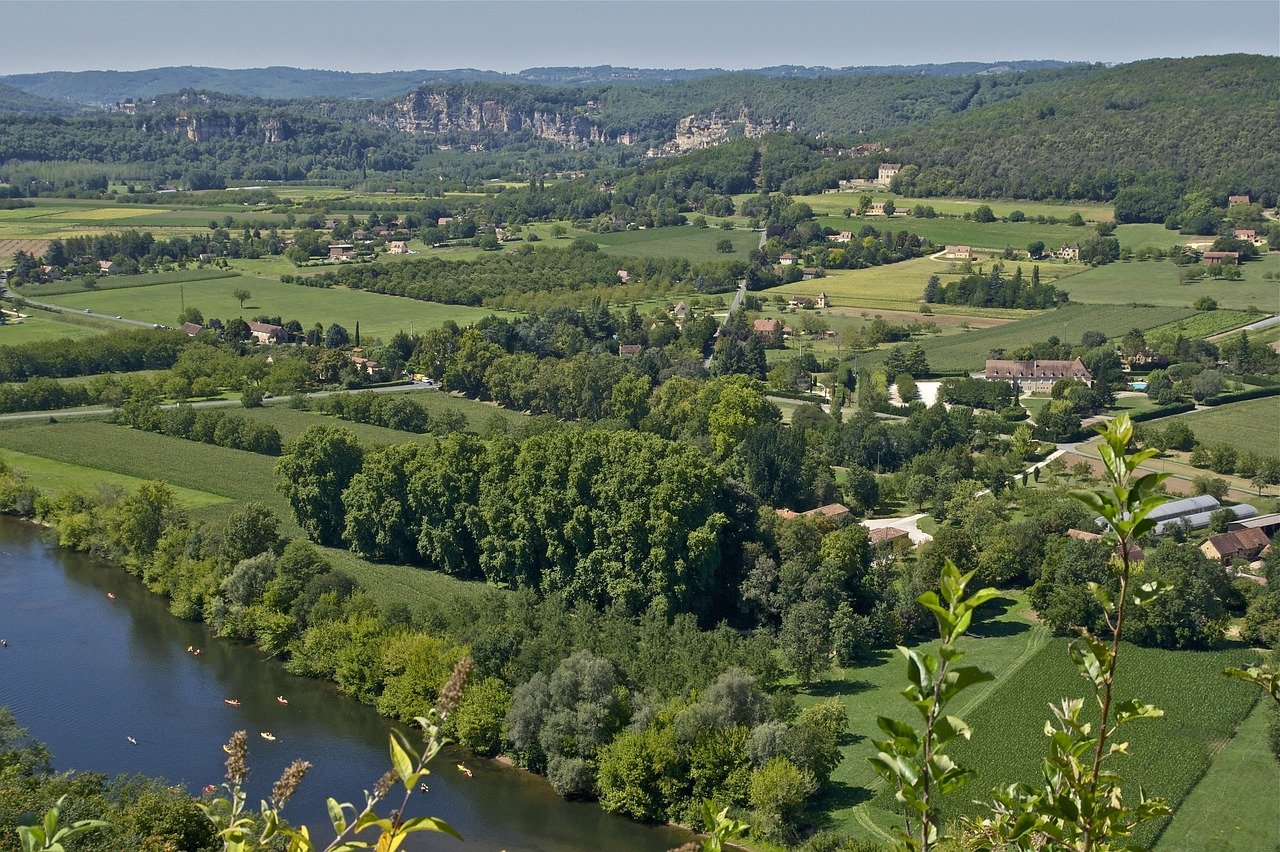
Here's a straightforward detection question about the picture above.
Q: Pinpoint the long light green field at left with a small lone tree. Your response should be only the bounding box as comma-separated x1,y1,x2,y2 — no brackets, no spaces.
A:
36,272,500,340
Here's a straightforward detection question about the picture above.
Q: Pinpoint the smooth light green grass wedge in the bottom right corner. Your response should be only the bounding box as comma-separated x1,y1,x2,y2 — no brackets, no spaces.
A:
1156,698,1280,852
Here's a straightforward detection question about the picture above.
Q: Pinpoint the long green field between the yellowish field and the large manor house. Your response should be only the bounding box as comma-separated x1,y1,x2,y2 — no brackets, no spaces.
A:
860,304,1192,370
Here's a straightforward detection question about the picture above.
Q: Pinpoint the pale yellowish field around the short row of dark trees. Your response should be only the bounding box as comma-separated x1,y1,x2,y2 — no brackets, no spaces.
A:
763,257,1082,317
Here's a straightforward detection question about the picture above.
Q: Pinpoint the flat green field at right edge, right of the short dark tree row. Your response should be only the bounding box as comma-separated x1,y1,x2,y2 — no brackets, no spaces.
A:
1042,252,1280,313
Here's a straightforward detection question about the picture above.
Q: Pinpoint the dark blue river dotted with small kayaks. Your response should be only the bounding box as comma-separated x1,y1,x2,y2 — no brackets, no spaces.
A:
0,517,689,852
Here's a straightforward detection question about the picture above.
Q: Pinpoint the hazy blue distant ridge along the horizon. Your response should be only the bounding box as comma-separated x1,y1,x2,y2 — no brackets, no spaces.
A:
0,60,1073,106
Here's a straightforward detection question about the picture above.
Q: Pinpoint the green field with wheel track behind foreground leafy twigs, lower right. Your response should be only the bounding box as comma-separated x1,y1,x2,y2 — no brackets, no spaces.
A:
800,594,1264,848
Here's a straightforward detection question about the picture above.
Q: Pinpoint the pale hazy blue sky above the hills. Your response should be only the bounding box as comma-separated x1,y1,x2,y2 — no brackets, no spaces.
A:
0,0,1280,74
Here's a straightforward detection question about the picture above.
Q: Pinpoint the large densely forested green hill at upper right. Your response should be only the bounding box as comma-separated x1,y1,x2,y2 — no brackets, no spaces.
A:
888,54,1280,200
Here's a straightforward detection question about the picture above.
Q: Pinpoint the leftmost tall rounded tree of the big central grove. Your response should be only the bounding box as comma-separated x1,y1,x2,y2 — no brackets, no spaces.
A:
275,426,364,545
